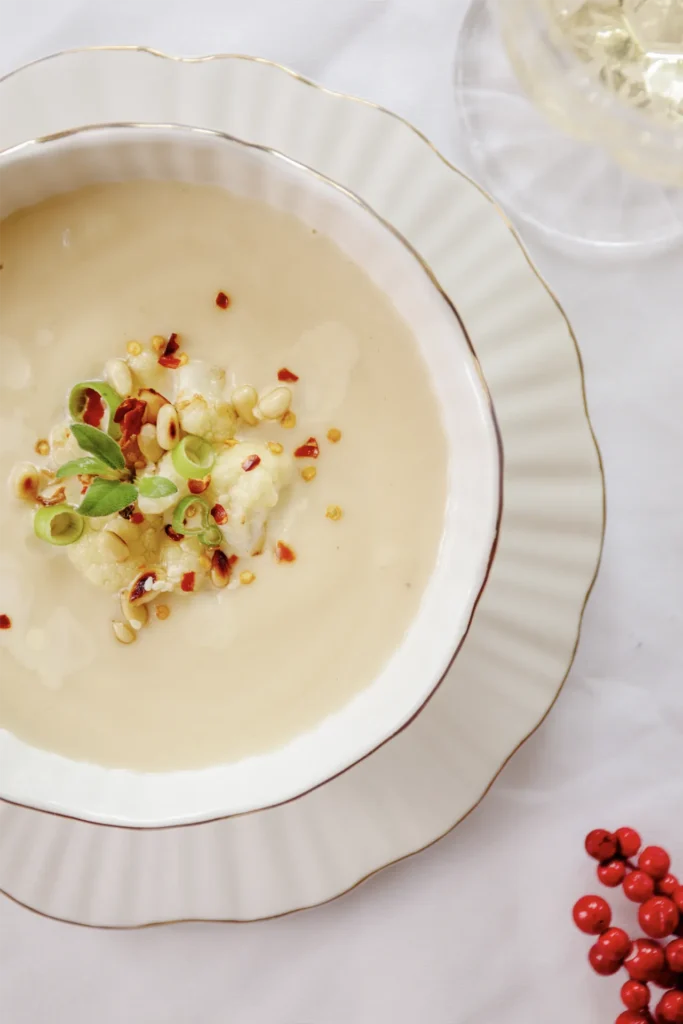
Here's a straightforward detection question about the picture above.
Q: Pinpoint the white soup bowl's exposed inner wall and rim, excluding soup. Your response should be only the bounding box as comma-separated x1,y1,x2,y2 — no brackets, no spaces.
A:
0,125,502,826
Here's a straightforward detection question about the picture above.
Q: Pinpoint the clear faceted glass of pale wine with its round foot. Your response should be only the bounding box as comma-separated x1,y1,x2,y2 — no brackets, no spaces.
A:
456,0,683,253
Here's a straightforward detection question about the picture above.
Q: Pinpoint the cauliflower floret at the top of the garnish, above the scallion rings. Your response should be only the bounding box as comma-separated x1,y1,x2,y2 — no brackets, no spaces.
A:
175,359,238,444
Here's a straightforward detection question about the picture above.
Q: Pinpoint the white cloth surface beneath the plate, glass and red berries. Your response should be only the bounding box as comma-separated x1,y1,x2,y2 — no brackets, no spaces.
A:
0,0,683,1024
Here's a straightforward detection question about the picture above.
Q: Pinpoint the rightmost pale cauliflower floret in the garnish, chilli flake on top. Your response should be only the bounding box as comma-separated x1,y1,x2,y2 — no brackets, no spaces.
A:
211,441,292,557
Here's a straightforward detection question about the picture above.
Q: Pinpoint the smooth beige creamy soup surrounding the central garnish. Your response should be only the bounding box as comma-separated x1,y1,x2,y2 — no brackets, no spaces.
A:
0,182,446,770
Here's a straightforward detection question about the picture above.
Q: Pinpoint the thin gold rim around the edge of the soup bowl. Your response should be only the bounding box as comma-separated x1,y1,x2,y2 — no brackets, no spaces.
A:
0,121,504,831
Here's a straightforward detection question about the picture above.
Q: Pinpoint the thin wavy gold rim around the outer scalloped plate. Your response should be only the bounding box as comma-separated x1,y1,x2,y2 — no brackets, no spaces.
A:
0,46,606,931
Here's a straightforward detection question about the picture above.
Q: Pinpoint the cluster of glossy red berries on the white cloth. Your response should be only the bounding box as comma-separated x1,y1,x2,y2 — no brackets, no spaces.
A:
573,828,683,1024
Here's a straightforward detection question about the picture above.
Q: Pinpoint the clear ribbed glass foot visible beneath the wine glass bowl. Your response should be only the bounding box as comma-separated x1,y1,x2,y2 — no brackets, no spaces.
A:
456,0,683,255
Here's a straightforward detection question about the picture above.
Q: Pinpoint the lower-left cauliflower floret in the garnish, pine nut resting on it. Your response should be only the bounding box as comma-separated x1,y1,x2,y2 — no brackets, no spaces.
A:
66,516,163,593
